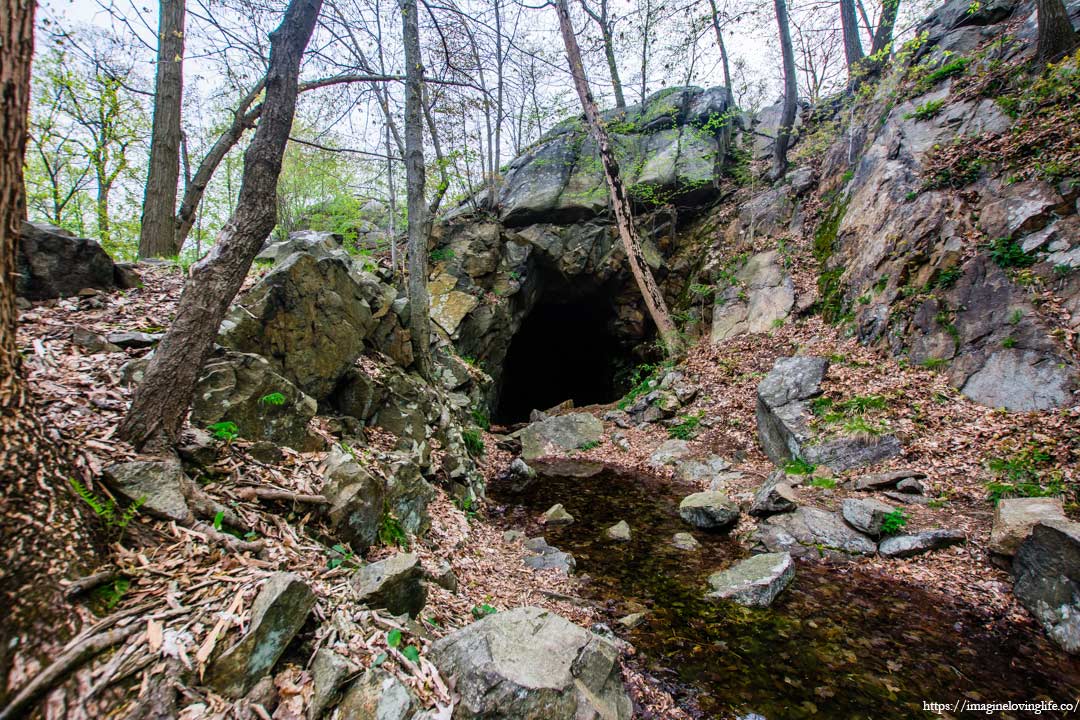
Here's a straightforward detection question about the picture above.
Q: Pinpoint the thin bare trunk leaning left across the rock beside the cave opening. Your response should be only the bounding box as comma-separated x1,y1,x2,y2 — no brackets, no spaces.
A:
555,0,683,355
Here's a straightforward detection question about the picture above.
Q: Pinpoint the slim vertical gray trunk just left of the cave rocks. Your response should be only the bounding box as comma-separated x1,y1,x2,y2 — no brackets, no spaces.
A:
401,0,432,380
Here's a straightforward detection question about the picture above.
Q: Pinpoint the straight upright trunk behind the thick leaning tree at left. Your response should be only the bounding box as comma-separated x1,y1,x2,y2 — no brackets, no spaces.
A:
138,0,185,258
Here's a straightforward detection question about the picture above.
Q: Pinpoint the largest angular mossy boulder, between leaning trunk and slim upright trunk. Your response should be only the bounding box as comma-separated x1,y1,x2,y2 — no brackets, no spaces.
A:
218,253,396,400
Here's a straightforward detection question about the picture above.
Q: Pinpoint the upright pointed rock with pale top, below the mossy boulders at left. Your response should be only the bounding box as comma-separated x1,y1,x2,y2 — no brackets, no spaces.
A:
322,446,386,553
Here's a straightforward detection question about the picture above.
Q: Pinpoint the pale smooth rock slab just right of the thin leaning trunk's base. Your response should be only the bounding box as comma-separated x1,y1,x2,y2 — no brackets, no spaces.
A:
711,250,795,342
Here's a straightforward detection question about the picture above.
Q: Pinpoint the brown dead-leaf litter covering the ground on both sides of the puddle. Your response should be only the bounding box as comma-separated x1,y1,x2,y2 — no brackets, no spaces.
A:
15,266,1080,718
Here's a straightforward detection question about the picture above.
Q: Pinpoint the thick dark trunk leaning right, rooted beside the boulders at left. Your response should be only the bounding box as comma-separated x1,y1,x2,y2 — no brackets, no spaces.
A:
120,0,322,449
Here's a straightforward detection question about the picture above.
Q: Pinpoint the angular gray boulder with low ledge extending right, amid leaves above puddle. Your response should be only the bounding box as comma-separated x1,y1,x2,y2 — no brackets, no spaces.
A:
755,357,900,472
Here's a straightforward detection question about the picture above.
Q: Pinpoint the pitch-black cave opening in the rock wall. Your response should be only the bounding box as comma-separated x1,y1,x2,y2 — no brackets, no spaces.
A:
495,297,625,424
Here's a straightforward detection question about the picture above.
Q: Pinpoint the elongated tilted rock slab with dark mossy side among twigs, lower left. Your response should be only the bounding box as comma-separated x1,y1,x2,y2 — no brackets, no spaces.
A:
207,572,315,697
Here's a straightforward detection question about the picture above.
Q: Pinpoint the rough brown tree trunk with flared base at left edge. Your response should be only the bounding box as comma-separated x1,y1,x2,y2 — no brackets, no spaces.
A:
0,0,104,707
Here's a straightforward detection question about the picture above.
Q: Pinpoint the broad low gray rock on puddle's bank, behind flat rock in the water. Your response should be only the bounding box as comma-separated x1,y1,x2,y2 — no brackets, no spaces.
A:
757,507,877,560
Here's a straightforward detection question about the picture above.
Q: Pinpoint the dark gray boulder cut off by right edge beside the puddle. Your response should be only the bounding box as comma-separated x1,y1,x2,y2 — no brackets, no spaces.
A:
1013,520,1080,654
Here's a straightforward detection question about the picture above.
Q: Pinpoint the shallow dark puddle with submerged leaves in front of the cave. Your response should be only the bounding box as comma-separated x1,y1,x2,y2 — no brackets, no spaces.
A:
490,472,1080,720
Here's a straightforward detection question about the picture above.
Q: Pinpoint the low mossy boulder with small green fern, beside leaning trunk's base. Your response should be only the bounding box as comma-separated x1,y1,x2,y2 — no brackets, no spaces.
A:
191,353,322,451
